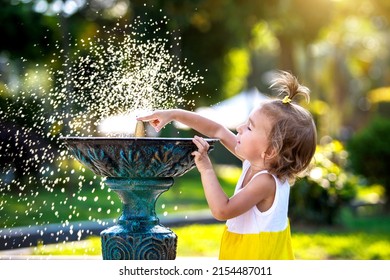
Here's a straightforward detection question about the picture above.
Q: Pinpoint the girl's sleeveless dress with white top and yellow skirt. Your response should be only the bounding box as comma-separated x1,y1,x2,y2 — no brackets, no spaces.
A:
219,162,294,260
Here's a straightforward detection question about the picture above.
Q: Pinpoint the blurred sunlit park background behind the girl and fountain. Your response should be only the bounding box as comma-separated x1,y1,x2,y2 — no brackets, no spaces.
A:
0,0,390,259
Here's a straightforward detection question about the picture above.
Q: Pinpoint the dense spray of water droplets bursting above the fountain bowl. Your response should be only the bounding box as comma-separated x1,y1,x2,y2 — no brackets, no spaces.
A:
49,20,201,136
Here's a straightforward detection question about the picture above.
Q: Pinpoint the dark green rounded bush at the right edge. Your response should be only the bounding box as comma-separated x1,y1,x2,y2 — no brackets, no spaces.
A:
347,117,390,208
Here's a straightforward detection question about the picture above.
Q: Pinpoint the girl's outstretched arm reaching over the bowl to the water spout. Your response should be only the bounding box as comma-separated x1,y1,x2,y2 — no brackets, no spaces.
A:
137,109,237,158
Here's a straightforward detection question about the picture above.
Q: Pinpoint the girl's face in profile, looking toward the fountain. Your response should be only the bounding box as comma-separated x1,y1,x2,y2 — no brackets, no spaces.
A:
235,107,272,165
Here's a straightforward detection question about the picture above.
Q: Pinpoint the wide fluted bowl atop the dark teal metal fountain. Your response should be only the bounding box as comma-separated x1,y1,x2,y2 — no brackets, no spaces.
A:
60,136,218,178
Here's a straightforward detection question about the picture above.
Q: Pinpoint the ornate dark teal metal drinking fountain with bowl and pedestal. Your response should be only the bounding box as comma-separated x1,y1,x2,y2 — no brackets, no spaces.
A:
61,137,217,260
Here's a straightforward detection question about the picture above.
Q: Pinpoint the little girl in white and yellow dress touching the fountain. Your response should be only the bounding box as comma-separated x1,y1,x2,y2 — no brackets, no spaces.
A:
138,72,317,260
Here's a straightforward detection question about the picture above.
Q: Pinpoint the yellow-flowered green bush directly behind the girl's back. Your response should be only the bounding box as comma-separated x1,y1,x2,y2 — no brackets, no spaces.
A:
289,141,358,225
